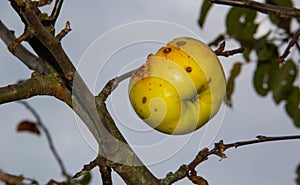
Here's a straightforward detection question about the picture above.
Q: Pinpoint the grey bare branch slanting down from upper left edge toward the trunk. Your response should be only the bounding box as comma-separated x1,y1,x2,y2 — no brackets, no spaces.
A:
0,20,49,74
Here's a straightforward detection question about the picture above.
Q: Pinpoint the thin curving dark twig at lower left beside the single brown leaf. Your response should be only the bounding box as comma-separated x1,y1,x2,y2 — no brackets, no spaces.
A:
18,101,68,176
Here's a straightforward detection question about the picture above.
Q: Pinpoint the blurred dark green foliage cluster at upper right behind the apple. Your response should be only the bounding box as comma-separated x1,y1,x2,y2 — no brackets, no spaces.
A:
198,0,300,185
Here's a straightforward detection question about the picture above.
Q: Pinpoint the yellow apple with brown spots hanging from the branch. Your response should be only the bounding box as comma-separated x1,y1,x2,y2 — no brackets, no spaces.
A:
128,37,226,135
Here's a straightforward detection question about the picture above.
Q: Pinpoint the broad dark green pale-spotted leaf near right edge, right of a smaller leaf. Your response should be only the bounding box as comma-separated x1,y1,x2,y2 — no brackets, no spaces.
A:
269,60,298,104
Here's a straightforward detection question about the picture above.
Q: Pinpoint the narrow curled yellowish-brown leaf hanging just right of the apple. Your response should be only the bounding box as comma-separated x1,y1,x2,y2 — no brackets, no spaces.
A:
225,62,242,107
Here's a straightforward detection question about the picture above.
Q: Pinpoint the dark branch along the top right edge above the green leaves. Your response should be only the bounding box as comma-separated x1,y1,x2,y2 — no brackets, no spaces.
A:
207,0,300,20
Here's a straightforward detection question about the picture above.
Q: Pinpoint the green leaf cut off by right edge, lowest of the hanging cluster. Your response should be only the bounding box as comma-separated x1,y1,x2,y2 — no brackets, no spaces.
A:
285,87,300,127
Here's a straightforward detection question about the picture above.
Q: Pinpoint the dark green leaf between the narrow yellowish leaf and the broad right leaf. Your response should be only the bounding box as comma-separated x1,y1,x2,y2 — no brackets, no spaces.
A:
253,62,270,96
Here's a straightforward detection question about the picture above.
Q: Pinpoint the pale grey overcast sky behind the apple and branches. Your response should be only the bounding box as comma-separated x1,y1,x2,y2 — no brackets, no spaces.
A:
0,0,300,185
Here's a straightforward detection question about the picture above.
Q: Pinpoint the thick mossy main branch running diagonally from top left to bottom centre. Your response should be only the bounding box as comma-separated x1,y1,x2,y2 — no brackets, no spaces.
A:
2,0,162,184
